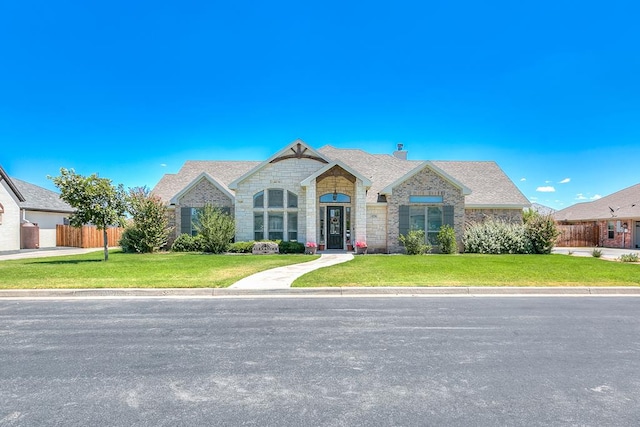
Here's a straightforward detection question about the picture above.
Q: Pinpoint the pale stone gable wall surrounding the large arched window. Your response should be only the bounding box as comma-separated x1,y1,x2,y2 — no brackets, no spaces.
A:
236,158,324,243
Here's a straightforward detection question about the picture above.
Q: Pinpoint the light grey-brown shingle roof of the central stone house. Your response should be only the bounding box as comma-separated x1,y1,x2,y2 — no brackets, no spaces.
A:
153,145,530,208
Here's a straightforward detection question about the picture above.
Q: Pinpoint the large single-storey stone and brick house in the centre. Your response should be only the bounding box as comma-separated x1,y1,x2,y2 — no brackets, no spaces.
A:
152,140,530,253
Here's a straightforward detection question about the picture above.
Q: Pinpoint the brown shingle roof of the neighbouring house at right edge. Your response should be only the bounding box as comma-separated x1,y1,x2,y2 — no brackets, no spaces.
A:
553,184,640,221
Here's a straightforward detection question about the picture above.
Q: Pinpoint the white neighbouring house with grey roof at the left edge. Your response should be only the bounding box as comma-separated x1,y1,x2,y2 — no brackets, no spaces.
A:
0,167,74,251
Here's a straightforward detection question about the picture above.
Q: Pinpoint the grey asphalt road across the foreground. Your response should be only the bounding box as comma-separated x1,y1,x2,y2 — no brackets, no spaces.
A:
0,297,640,426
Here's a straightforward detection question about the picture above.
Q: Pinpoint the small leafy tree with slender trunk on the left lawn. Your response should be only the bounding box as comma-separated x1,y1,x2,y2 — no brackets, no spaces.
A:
48,168,126,261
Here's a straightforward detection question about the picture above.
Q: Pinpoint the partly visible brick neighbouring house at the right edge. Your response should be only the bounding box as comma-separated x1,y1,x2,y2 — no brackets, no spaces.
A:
553,184,640,248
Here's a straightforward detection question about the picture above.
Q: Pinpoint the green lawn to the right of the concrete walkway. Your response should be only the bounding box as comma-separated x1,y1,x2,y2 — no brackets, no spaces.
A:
293,254,640,287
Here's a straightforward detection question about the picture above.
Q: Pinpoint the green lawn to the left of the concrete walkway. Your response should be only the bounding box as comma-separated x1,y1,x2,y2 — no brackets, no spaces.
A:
0,251,318,289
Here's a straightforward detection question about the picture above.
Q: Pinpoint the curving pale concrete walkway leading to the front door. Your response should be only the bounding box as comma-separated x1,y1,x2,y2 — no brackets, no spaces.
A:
229,253,353,290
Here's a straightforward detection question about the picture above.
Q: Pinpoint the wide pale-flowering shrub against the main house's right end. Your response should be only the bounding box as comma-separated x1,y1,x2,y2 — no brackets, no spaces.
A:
463,219,533,254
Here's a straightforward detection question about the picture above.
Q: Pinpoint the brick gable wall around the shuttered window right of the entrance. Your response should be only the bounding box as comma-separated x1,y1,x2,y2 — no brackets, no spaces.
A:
387,166,465,252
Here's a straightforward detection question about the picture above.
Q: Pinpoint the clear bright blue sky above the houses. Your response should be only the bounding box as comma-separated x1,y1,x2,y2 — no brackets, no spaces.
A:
0,0,640,209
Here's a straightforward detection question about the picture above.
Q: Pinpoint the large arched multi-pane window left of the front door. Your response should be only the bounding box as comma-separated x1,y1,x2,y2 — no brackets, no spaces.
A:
253,188,298,241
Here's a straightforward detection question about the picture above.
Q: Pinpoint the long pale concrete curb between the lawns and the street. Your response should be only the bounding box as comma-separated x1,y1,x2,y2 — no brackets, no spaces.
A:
0,286,640,299
